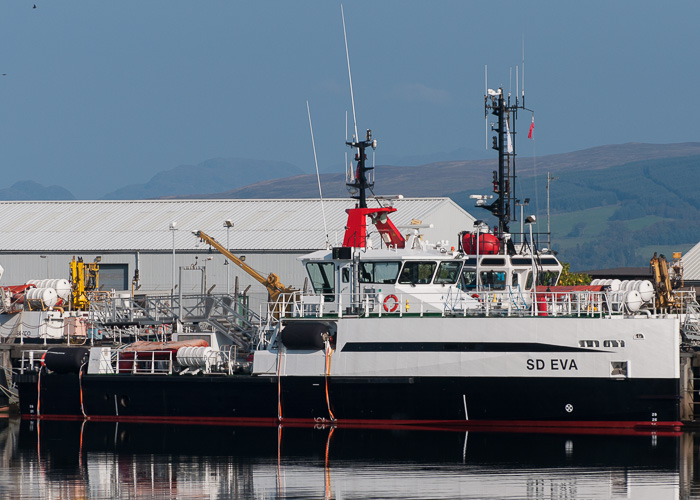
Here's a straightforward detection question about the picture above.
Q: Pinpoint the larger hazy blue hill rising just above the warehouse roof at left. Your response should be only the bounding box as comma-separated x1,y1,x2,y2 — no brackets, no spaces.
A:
103,158,303,200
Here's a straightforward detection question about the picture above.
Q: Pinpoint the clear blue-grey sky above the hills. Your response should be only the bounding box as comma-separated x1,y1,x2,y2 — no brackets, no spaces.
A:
0,0,700,199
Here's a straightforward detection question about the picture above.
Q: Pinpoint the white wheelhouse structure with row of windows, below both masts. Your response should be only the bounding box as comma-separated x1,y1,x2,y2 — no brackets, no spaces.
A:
302,250,562,308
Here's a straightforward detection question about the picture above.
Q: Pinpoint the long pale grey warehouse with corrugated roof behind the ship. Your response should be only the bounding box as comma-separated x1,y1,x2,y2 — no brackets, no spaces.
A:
0,198,474,308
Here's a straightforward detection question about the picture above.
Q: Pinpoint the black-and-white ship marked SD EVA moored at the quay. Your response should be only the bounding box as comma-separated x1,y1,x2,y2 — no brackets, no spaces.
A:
17,84,682,432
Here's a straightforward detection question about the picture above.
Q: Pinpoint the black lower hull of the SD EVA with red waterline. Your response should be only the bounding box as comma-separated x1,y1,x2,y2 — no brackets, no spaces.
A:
18,373,680,428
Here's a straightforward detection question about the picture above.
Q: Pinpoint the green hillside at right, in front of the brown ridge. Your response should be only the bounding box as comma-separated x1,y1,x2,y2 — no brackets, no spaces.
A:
453,154,700,271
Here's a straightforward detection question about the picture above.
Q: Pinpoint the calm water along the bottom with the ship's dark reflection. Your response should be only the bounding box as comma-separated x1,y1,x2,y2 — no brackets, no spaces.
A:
0,420,700,500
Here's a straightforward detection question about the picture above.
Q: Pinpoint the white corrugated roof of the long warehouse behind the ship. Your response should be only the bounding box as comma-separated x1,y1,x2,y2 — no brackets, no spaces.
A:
0,198,473,252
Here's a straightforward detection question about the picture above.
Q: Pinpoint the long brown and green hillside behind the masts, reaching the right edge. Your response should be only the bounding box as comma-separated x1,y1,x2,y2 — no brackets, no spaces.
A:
168,143,700,271
